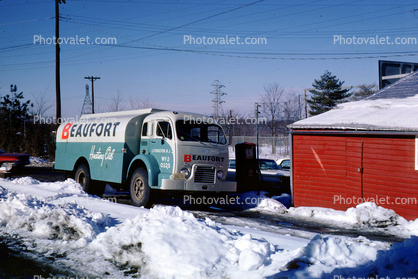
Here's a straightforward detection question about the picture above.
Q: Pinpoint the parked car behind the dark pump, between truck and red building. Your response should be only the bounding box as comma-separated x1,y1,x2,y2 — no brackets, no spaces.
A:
227,159,290,194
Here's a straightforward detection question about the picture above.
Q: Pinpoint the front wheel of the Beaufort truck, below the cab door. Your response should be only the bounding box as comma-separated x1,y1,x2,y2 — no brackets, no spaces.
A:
129,168,151,206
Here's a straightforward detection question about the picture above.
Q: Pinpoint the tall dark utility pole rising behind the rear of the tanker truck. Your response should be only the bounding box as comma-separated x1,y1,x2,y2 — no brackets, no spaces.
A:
55,0,65,125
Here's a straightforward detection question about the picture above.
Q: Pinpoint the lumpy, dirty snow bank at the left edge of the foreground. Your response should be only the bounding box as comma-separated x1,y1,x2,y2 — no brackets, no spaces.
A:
0,187,108,246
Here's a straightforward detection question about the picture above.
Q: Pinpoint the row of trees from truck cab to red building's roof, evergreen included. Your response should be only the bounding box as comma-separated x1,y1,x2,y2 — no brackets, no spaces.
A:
220,71,377,136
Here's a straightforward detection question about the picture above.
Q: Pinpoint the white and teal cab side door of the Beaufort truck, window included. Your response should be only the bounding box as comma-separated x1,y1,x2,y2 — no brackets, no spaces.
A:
149,119,176,185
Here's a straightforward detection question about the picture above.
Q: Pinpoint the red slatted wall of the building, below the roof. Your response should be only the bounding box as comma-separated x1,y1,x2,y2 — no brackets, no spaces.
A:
292,134,418,220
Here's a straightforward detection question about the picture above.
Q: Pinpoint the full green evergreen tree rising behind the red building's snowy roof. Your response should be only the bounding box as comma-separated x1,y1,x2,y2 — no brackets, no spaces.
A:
306,71,351,116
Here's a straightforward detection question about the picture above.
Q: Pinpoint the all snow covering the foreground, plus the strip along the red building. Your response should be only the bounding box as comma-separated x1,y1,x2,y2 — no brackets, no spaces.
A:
0,177,418,279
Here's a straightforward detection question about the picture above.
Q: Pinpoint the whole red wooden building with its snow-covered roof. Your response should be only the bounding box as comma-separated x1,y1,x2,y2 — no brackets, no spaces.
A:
290,72,418,220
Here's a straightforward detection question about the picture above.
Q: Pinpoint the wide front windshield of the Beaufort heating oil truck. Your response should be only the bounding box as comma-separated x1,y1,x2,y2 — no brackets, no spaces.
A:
176,120,226,144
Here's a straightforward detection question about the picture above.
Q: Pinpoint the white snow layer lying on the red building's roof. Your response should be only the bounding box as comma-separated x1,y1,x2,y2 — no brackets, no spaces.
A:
289,95,418,131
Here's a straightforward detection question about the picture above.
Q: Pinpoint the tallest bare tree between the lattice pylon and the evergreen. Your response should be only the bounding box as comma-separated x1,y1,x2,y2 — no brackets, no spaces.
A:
260,83,284,136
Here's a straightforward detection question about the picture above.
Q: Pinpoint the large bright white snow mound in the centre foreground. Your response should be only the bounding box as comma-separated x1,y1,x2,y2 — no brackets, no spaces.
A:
90,206,275,278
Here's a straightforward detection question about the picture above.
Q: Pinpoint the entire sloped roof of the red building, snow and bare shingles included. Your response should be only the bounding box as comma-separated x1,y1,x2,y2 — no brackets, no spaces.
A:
289,71,418,132
